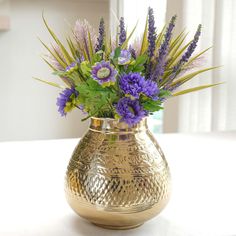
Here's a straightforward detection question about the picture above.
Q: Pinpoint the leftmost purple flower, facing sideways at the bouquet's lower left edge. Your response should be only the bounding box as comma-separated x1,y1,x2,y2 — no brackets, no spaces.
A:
57,87,79,116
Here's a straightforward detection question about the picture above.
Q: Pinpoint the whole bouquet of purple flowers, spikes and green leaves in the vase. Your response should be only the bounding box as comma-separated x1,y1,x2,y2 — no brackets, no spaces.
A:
38,8,220,126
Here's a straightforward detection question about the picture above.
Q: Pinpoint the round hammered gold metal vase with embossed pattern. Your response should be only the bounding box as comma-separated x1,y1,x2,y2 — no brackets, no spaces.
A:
65,118,170,229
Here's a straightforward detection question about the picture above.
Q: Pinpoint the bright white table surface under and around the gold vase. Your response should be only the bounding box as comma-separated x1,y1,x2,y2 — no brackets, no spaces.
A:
0,132,236,236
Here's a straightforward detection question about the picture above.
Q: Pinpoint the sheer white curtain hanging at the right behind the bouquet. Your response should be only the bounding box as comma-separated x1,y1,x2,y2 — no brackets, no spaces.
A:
177,0,236,132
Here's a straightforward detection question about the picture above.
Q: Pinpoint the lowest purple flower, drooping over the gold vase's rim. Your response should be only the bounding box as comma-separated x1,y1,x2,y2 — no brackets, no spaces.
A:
116,97,147,126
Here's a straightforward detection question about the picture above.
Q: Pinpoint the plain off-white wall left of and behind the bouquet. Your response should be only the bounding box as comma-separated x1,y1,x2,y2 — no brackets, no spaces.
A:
0,0,109,141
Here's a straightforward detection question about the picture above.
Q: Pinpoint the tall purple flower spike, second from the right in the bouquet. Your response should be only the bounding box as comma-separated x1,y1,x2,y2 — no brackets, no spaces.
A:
152,15,177,82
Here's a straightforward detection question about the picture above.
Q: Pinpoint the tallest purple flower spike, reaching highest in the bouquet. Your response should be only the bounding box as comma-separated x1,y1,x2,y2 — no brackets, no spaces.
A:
148,7,157,58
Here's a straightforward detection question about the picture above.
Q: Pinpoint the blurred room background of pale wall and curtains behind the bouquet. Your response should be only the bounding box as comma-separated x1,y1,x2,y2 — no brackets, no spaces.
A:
0,0,236,141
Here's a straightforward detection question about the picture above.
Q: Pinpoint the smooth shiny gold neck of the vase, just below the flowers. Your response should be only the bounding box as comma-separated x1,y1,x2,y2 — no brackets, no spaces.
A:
89,117,148,133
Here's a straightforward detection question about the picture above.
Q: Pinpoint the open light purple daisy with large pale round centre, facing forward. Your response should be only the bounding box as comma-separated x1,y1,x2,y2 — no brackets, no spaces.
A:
92,61,117,86
